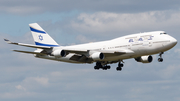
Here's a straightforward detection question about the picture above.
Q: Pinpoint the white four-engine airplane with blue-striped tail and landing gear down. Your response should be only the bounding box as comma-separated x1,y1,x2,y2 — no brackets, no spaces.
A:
4,23,177,71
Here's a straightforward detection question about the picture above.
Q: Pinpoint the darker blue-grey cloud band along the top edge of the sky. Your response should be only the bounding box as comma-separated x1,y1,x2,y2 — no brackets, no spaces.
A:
0,0,180,15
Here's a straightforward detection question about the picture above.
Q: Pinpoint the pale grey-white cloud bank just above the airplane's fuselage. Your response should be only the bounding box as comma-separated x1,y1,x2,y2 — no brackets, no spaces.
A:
67,11,180,38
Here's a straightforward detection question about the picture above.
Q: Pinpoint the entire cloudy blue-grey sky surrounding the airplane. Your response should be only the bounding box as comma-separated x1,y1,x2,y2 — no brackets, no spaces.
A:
0,0,180,101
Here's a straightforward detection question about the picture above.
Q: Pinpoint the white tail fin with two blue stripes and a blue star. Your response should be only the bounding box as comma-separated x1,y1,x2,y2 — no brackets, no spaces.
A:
29,23,59,47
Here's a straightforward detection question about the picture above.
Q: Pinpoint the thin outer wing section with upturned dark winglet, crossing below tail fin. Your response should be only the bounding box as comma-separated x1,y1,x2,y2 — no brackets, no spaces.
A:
4,39,52,49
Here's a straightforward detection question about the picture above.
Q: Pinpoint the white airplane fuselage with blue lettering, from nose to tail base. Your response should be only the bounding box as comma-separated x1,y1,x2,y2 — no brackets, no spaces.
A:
38,31,177,63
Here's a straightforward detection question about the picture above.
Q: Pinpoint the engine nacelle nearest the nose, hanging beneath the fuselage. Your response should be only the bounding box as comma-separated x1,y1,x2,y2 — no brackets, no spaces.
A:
135,55,153,63
